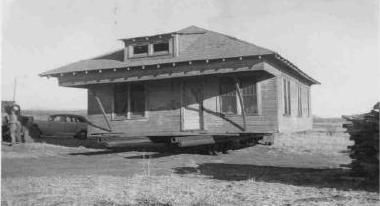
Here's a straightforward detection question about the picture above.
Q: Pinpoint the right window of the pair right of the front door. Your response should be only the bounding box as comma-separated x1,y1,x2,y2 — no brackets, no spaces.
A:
240,80,259,115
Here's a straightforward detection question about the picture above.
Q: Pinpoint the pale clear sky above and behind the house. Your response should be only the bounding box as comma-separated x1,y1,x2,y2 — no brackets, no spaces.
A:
1,0,380,117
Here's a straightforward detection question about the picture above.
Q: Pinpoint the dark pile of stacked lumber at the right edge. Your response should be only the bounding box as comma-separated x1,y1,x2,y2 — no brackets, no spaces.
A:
342,103,379,178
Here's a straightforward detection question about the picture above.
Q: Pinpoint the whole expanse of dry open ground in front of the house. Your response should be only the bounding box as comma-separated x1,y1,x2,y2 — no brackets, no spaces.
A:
1,118,379,205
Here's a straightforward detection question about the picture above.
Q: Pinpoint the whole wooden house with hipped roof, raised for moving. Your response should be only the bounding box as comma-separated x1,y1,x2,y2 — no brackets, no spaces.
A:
40,26,319,148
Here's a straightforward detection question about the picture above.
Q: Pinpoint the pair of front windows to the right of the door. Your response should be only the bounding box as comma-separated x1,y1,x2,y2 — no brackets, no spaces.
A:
220,79,259,115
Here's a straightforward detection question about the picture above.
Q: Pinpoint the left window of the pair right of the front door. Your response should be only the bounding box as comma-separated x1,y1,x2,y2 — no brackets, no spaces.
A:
220,79,237,114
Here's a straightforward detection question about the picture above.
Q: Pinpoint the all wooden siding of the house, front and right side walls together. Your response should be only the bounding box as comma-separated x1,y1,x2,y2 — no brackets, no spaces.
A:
88,58,312,135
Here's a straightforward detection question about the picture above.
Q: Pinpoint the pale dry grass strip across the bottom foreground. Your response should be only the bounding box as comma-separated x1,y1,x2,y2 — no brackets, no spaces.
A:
2,175,379,206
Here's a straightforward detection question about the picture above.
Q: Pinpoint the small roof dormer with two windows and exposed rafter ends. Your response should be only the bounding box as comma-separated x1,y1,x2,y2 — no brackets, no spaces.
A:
122,34,178,61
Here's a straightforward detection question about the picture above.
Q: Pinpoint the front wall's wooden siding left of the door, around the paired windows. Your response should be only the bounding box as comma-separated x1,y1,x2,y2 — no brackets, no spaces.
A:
88,81,180,135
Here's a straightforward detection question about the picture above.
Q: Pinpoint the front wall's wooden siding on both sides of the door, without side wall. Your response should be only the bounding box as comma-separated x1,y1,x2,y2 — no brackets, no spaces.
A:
88,72,278,135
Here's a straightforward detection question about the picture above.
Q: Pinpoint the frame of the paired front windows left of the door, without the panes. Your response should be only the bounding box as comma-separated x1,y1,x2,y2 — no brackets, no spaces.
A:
112,83,148,121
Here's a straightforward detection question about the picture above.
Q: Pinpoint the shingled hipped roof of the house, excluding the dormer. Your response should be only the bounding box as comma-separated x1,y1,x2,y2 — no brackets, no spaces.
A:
40,26,319,84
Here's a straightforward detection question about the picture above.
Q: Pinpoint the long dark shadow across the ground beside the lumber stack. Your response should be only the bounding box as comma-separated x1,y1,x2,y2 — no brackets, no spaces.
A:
174,163,379,192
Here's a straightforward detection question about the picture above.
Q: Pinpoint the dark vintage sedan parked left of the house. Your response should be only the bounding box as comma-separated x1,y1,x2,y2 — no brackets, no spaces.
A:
31,114,88,139
